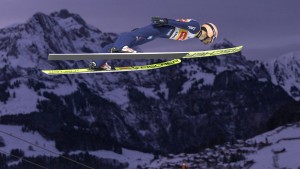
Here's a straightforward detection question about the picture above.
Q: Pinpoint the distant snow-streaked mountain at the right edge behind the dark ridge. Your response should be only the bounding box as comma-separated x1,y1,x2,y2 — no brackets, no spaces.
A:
265,52,300,100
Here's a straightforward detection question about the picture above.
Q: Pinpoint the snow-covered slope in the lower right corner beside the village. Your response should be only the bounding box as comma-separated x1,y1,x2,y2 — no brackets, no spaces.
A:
246,123,300,169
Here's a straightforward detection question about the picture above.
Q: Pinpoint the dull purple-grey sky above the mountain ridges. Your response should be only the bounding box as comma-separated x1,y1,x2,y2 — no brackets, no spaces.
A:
0,0,300,60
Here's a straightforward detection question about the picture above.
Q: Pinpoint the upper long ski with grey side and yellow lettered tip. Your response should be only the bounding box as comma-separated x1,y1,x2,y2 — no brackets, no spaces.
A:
48,46,243,60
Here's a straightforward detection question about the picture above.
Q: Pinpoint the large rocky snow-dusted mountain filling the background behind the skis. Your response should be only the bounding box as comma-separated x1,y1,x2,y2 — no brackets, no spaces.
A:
0,10,296,157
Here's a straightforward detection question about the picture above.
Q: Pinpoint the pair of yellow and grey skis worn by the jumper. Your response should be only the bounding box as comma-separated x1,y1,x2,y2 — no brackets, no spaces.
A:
42,46,243,75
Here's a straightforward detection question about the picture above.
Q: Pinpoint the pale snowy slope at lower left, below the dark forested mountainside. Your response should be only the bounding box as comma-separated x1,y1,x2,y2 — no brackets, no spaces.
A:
0,125,153,169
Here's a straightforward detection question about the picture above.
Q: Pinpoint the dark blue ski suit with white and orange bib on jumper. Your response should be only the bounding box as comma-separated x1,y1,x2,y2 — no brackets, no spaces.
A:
96,19,200,65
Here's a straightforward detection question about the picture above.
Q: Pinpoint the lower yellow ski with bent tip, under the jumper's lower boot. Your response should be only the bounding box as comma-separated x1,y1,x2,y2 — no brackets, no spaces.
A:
42,59,181,75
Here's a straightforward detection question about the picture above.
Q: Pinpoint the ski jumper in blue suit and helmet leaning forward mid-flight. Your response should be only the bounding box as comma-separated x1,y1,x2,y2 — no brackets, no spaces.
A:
90,17,218,70
